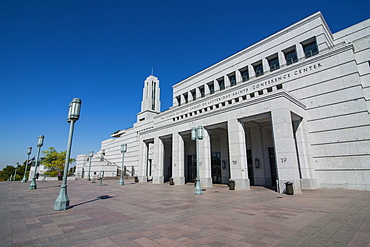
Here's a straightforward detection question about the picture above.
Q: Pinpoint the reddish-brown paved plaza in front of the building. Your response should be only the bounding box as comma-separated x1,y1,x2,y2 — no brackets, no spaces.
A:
0,179,370,247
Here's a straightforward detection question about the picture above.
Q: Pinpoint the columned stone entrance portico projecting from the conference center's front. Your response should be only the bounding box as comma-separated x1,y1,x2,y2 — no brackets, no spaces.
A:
145,93,310,193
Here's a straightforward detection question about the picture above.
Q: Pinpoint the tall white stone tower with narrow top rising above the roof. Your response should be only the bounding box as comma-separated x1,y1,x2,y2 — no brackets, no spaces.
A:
137,75,161,122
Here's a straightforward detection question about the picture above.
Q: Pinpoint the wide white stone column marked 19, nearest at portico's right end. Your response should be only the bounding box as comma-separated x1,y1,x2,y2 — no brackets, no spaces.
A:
271,108,302,193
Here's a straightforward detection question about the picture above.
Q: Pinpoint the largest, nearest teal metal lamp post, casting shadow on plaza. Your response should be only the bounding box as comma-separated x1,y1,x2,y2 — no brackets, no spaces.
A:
54,98,82,211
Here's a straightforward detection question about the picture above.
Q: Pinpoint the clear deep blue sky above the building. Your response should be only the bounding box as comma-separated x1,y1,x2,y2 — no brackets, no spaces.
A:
0,0,370,169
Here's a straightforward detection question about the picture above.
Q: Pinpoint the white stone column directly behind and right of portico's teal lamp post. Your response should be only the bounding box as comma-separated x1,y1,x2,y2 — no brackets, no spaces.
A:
199,128,212,187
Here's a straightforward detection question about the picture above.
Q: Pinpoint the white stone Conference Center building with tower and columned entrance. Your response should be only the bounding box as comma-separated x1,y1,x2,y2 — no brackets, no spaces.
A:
76,12,370,193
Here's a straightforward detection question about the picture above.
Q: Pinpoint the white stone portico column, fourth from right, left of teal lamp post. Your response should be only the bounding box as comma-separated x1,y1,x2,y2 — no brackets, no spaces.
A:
172,132,185,185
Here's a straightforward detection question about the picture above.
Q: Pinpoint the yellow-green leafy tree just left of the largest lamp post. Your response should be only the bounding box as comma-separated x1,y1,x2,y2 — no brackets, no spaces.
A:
41,147,75,177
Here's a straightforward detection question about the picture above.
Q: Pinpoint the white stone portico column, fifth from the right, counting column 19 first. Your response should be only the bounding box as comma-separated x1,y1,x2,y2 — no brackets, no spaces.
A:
153,137,164,184
